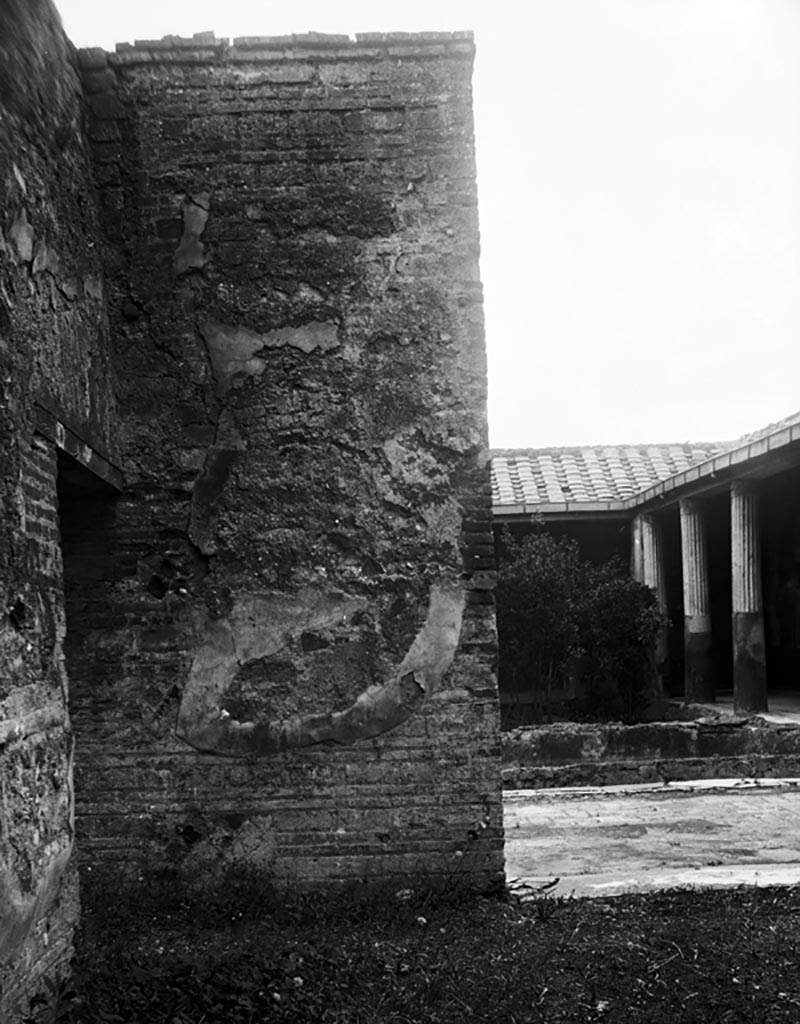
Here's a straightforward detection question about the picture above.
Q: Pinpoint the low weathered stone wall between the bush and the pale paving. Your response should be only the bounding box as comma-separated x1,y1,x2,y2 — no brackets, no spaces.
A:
503,718,800,790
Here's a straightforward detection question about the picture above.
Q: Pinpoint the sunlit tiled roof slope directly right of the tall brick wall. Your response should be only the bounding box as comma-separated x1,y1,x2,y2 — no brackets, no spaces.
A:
492,443,728,507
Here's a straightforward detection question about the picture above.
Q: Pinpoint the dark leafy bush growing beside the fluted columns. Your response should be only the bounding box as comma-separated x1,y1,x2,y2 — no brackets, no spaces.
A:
497,527,664,725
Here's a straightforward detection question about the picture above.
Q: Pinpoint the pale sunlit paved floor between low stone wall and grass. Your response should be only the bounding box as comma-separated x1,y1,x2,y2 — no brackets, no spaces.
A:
505,779,800,896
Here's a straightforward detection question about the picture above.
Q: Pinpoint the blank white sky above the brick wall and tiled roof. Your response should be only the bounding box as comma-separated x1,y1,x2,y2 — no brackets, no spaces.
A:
55,0,800,447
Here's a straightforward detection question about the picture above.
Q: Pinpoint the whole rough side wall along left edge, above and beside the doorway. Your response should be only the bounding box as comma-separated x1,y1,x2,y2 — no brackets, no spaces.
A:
0,0,114,1021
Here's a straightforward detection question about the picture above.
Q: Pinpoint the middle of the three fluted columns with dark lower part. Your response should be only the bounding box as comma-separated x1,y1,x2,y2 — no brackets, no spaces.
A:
680,499,715,701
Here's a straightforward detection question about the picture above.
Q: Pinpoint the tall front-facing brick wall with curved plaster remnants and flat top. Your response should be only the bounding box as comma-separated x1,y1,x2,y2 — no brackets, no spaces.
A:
66,35,503,887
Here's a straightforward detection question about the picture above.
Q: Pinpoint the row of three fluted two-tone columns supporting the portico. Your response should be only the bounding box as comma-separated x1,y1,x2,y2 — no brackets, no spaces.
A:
631,480,767,712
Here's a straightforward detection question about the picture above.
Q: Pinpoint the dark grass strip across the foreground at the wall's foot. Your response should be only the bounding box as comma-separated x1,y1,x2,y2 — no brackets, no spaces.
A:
23,872,800,1024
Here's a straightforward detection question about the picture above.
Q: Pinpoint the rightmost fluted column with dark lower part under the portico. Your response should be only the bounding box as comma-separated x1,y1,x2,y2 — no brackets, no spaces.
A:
730,480,767,712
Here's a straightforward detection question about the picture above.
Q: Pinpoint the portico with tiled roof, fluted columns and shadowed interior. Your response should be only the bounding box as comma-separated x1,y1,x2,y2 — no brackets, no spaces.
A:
494,413,800,713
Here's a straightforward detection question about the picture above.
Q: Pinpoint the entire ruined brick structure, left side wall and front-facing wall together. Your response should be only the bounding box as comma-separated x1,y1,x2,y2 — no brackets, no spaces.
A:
0,9,503,1019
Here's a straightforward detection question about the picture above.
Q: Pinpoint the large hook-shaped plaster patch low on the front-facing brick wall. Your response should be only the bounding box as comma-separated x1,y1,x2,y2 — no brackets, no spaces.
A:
177,585,465,757
